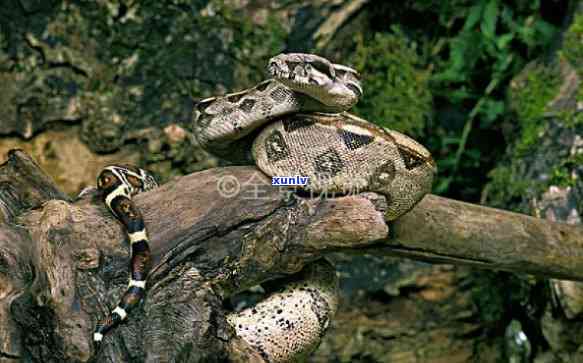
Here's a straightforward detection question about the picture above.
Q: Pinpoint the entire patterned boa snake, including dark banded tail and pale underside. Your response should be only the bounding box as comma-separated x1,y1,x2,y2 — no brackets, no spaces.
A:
94,53,436,362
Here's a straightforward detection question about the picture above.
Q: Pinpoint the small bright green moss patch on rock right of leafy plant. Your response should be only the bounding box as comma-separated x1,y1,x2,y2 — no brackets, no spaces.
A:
509,62,561,156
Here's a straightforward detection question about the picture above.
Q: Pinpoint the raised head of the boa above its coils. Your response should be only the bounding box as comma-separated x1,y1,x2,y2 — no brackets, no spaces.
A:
267,53,362,112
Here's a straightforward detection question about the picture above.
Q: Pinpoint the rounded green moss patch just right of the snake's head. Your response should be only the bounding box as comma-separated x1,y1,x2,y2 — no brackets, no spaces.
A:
350,33,432,135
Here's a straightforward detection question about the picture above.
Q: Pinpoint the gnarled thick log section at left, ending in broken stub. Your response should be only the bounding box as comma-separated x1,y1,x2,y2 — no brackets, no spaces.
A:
0,154,387,362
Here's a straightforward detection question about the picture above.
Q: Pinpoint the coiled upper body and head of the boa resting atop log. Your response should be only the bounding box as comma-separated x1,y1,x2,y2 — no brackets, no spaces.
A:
194,54,436,219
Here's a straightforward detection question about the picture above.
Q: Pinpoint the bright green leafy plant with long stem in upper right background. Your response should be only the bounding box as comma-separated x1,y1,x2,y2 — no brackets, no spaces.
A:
433,0,555,196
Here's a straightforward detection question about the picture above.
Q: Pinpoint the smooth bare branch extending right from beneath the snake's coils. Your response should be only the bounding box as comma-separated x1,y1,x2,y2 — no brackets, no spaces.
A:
378,195,583,281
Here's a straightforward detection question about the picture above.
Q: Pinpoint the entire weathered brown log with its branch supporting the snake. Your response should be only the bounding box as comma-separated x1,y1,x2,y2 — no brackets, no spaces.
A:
0,152,583,362
